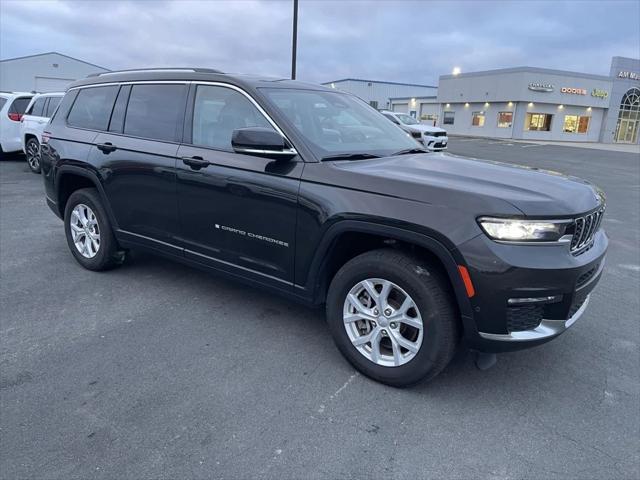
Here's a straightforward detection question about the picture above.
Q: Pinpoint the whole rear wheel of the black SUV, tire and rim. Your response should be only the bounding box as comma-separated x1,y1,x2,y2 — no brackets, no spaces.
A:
64,188,124,270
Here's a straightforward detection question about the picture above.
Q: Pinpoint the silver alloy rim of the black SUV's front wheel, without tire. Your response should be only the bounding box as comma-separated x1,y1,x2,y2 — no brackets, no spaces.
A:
343,278,424,367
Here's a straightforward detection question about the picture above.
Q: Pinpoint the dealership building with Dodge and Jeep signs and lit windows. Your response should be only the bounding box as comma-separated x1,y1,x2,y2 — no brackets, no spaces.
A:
391,57,640,143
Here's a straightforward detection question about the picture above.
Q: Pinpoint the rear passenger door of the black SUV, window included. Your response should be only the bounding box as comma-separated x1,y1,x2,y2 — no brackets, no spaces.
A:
91,82,188,251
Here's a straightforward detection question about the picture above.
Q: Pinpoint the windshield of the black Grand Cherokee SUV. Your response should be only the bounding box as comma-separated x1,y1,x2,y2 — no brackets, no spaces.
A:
263,88,418,158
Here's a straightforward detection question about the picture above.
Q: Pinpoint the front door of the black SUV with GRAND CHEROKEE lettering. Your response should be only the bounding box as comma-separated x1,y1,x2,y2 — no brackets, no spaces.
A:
177,84,304,289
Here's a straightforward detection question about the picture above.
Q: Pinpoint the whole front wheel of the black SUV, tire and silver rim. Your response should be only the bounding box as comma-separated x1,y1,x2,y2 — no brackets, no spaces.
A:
327,249,460,387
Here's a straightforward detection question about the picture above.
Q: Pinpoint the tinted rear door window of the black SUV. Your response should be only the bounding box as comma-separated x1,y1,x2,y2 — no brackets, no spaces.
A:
124,85,186,142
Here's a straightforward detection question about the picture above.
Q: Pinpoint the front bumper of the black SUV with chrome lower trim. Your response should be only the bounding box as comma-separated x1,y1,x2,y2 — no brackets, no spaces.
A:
460,230,608,352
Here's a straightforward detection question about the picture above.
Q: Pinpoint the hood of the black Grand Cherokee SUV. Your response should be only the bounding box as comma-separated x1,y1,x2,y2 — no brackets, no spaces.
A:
335,153,604,217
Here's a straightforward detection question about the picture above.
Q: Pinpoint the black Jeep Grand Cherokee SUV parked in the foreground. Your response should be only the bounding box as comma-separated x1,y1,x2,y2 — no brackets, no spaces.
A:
37,69,608,385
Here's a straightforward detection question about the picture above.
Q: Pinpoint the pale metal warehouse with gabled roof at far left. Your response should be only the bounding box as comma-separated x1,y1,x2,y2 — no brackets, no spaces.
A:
0,52,109,92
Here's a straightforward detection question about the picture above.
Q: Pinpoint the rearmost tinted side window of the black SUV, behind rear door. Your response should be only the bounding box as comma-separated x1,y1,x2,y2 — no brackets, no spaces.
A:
67,86,118,130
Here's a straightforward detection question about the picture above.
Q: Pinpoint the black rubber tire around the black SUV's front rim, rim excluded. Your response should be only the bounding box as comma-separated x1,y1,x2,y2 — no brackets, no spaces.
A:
326,249,460,387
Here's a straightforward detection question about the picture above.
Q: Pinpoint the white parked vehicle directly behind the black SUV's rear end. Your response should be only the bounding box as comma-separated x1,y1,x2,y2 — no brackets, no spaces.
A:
20,92,64,173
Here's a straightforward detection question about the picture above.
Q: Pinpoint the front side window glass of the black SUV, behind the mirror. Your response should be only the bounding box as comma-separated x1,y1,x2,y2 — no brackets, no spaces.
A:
193,85,272,151
